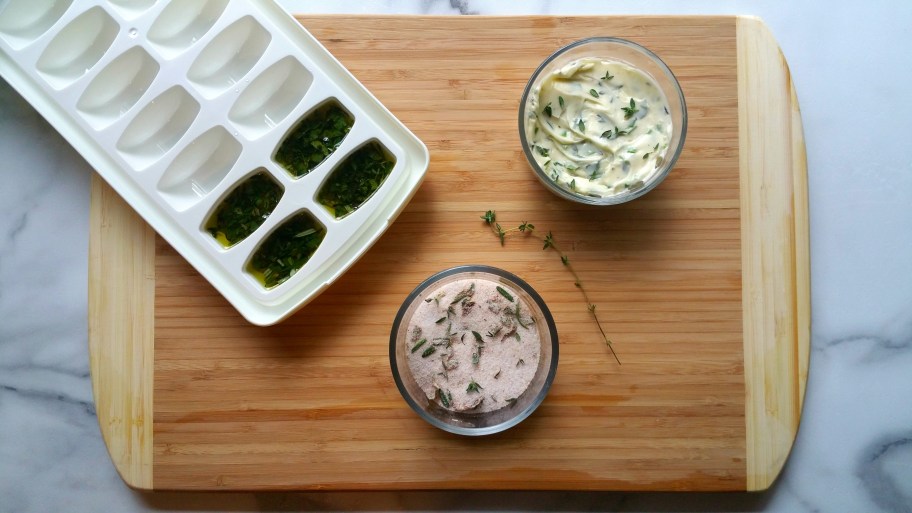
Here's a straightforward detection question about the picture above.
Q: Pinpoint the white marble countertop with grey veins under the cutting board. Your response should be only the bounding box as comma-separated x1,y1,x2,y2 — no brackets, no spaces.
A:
0,0,912,513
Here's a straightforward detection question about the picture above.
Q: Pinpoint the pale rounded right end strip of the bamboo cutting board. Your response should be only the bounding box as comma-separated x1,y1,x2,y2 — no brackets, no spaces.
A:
737,16,810,491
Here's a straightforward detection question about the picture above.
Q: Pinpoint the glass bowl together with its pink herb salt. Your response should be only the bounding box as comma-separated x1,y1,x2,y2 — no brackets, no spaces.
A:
390,265,558,436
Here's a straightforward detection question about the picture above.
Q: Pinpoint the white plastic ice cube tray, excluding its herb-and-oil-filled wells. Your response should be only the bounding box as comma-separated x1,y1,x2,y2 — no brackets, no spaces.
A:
0,0,429,325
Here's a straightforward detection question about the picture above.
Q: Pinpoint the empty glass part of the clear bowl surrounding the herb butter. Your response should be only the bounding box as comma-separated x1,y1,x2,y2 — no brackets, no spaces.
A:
519,37,687,205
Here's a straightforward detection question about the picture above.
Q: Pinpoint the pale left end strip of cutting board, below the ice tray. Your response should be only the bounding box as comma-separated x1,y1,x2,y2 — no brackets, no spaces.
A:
88,175,155,490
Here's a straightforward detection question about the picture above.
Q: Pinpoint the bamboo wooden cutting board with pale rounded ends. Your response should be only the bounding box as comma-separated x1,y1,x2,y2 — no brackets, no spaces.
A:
89,16,810,490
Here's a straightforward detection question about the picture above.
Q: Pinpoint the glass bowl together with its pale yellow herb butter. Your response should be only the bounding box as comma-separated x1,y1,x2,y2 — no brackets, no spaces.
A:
519,37,687,205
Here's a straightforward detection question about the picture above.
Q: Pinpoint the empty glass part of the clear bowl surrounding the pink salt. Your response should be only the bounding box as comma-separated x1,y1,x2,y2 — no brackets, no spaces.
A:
390,265,558,436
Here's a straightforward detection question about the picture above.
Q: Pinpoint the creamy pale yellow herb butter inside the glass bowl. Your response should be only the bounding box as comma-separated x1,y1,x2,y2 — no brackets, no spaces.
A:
525,57,672,197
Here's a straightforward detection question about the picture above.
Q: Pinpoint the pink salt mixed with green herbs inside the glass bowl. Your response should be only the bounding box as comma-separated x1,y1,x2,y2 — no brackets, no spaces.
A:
405,279,541,413
